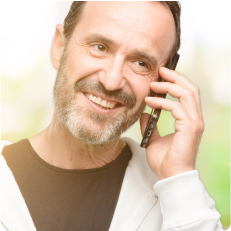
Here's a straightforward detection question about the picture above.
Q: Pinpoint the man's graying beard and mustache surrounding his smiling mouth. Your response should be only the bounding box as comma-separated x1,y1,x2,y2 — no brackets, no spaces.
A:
53,48,145,145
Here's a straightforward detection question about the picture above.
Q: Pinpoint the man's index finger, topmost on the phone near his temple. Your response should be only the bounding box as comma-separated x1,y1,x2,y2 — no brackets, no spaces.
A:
159,67,202,117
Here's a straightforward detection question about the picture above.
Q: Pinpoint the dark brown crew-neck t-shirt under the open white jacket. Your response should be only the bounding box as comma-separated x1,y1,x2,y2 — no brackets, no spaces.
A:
3,139,132,231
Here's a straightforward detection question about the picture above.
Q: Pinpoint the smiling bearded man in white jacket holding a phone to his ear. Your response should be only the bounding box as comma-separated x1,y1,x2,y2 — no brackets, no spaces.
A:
1,2,223,231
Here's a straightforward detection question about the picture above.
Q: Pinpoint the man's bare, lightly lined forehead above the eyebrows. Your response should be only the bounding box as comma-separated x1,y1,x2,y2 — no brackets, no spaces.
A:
72,1,175,60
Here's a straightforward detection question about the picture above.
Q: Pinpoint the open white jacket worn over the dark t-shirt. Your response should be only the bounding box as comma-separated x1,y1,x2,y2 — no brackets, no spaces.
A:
0,138,223,231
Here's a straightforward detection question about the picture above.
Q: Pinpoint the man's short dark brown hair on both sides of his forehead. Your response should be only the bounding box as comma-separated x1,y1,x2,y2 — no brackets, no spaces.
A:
64,1,181,67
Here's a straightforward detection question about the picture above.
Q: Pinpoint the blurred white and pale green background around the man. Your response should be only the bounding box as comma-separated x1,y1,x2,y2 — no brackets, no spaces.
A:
0,1,231,229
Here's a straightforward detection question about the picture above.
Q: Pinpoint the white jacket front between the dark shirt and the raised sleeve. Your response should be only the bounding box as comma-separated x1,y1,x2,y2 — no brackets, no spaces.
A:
110,138,158,231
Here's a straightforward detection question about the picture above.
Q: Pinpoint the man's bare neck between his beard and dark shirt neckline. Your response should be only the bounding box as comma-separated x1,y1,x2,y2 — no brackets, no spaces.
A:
29,114,125,169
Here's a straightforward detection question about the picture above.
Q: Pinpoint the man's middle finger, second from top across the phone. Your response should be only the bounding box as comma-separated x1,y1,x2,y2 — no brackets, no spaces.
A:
151,82,200,120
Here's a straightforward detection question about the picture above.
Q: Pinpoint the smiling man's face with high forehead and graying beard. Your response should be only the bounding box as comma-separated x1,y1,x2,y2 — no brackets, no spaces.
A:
54,2,175,144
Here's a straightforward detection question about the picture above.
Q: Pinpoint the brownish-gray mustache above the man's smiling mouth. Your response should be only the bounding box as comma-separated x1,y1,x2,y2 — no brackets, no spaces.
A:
74,78,136,109
